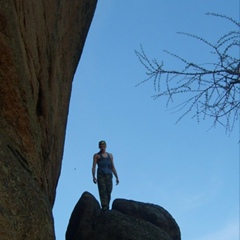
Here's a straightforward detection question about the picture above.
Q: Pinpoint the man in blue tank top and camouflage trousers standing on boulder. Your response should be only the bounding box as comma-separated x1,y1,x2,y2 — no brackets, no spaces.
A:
92,141,119,211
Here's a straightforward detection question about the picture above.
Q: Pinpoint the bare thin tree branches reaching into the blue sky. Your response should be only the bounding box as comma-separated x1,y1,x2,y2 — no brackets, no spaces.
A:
135,13,240,133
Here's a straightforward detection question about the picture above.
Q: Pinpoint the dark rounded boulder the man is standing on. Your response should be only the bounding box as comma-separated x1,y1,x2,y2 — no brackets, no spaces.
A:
66,192,181,240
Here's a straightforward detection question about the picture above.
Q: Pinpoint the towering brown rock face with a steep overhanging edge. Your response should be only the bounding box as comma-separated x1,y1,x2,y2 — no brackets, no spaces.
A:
0,0,97,240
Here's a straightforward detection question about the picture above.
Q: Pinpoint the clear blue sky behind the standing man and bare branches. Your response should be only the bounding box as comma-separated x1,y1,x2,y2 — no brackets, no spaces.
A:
54,0,239,240
